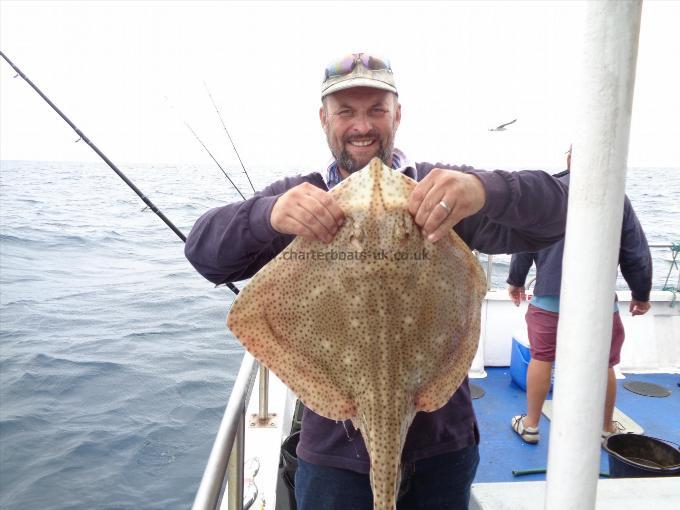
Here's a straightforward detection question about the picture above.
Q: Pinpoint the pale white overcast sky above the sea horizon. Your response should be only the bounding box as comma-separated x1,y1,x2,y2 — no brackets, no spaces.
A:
0,0,680,171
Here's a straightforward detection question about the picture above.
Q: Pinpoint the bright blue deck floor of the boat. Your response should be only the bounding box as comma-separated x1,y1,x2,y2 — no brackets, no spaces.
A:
470,367,680,483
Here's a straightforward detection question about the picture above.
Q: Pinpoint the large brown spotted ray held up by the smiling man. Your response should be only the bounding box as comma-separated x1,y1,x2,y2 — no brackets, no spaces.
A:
227,158,486,510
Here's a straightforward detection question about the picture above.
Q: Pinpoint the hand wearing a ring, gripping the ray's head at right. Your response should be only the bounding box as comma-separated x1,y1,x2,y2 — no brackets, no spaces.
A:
408,168,486,243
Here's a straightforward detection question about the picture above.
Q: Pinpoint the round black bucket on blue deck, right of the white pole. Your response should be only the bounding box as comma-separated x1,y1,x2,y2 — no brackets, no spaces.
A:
603,434,680,478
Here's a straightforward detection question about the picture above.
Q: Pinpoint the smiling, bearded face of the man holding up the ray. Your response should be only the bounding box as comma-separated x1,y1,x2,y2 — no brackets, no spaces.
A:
319,87,401,177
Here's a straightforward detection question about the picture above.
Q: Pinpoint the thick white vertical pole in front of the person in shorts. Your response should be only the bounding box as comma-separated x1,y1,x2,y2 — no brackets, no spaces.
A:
545,0,642,510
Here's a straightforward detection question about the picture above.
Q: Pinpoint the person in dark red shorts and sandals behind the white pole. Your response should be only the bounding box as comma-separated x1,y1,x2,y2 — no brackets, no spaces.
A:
507,149,652,444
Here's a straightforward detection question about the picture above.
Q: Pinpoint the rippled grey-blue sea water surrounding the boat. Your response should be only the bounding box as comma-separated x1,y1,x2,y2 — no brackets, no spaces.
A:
0,161,680,509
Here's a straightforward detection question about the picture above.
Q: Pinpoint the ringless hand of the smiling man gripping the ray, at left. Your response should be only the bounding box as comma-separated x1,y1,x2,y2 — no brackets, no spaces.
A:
270,182,345,243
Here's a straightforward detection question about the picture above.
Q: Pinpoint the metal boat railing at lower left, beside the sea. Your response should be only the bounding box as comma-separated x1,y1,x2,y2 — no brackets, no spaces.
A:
192,352,269,510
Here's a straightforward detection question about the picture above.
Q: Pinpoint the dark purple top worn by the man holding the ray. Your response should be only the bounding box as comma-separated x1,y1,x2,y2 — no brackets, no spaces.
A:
185,163,567,473
